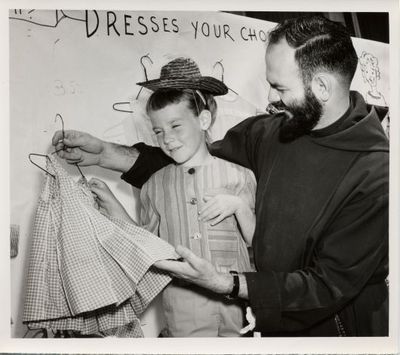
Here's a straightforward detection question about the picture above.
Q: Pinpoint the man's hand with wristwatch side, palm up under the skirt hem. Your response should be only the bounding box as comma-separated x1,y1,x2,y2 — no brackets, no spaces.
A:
154,246,233,294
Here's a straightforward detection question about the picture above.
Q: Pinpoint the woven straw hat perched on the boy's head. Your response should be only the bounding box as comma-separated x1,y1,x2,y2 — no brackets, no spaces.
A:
137,57,228,96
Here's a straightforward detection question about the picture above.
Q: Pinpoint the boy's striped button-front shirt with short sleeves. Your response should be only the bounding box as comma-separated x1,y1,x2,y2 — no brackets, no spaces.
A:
140,157,256,272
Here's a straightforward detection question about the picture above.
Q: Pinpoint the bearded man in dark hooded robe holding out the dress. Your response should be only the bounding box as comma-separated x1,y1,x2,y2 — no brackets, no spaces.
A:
53,16,389,336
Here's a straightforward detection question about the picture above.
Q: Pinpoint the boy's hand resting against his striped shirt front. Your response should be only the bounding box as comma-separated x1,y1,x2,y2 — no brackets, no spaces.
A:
199,194,244,226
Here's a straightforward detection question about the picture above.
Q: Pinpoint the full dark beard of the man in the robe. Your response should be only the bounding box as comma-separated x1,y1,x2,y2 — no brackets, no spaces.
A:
273,88,322,143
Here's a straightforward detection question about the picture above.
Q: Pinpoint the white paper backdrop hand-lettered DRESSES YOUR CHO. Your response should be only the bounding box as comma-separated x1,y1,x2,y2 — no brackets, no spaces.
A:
9,9,389,337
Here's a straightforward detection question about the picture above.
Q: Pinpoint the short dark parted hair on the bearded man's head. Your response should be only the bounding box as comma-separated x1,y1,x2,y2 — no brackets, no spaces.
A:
269,16,358,87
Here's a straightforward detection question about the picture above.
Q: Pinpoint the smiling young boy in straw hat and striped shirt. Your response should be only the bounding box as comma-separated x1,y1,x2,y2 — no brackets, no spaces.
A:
90,58,256,337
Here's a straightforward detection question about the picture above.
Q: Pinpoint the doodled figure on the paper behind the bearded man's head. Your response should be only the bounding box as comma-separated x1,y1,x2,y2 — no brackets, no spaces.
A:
359,51,387,106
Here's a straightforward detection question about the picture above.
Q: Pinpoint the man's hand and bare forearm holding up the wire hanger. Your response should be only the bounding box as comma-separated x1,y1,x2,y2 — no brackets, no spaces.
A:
52,130,139,173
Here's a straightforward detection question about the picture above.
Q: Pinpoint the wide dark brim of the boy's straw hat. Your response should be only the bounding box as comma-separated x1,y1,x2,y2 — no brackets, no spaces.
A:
136,76,228,96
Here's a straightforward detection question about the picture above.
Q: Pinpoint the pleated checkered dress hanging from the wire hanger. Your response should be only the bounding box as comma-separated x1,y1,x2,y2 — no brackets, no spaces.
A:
23,157,176,336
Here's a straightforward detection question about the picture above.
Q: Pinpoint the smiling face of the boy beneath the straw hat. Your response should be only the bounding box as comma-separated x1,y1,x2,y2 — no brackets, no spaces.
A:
149,101,208,166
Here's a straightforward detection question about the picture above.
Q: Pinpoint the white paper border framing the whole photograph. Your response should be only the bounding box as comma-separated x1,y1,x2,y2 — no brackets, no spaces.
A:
0,0,400,354
